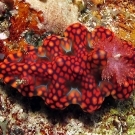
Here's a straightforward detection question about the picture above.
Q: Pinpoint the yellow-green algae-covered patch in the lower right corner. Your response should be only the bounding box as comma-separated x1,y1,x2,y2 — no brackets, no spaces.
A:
98,99,135,135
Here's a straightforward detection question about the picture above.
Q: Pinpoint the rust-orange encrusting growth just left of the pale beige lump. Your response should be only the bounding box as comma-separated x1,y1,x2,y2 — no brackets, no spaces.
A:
9,1,43,42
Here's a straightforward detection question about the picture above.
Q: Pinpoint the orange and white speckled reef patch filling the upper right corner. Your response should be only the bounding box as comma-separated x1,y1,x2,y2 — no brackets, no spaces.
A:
79,0,135,45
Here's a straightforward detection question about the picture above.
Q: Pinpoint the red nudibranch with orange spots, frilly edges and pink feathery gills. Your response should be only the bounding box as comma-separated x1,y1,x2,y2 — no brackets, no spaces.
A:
0,23,135,113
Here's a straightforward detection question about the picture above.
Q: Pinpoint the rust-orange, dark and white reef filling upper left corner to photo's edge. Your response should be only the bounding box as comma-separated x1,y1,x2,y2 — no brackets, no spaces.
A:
0,0,45,55
